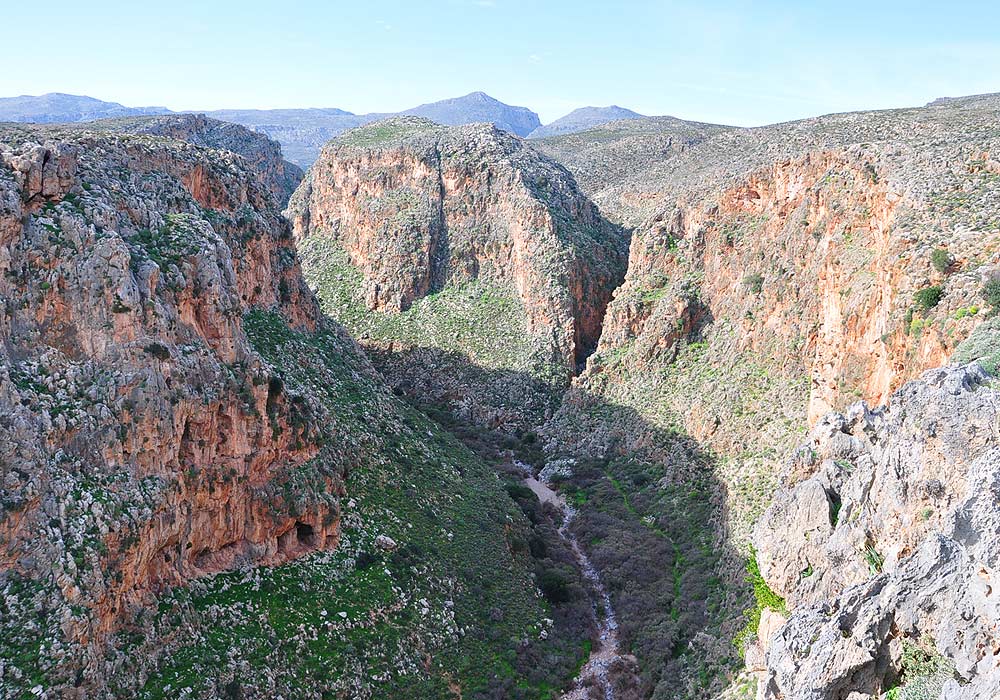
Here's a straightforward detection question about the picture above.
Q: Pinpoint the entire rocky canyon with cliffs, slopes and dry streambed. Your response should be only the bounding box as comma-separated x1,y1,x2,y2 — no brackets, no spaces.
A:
0,91,1000,700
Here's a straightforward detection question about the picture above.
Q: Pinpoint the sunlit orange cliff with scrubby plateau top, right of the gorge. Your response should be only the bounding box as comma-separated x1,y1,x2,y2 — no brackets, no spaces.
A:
548,98,1000,478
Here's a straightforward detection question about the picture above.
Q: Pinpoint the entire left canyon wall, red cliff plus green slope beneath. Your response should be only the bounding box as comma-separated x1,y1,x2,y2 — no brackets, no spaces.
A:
0,118,582,698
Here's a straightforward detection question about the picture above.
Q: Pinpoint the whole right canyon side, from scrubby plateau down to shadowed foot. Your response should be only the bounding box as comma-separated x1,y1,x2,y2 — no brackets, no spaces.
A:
524,95,1000,697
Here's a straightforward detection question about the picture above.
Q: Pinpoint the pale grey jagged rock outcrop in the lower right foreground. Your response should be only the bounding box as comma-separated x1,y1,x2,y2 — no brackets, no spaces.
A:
754,364,1000,700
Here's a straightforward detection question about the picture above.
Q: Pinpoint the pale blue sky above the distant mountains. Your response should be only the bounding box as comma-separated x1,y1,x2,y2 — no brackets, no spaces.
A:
0,0,1000,125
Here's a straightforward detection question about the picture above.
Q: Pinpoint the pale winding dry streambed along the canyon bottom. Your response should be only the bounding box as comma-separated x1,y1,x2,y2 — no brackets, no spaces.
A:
519,463,619,700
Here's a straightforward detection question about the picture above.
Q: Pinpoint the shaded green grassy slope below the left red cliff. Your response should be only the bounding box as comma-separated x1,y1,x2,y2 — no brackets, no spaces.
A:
108,312,580,698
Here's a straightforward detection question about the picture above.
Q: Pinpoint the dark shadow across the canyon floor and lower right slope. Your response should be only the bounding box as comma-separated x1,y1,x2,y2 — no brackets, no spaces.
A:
372,347,751,700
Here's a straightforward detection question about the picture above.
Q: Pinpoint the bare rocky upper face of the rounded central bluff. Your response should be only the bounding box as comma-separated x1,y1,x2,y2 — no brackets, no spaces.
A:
289,118,625,371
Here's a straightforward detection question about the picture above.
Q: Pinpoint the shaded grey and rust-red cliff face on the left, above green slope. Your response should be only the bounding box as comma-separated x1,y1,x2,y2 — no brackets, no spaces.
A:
0,120,341,668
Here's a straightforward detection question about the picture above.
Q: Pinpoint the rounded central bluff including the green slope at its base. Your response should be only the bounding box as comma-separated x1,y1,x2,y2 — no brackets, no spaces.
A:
288,118,626,429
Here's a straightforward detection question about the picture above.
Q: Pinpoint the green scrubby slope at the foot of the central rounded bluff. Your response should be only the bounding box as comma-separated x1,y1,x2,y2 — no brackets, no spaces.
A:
299,236,565,430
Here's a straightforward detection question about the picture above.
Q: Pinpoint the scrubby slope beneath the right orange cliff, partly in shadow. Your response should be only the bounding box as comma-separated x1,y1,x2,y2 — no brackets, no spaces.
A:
544,324,807,698
